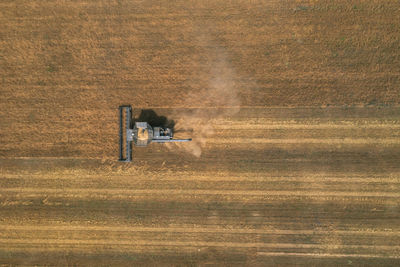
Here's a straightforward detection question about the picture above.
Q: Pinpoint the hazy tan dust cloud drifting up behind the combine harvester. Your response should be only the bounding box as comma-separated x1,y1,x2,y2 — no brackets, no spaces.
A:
171,47,240,157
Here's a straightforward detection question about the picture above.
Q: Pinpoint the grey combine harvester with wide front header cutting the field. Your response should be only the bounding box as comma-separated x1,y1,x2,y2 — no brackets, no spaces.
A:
119,106,192,162
